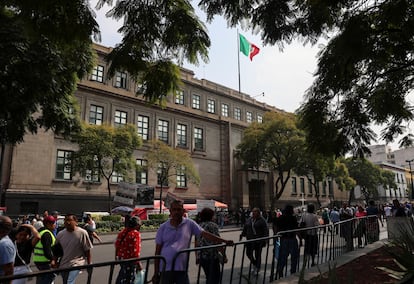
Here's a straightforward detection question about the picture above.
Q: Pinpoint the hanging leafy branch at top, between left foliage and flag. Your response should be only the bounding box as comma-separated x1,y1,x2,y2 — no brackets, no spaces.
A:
102,0,210,105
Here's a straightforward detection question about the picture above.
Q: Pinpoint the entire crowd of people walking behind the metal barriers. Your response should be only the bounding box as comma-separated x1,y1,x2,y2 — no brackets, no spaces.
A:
0,200,412,284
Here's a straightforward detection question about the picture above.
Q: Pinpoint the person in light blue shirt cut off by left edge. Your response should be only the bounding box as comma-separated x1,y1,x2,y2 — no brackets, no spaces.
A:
0,216,16,276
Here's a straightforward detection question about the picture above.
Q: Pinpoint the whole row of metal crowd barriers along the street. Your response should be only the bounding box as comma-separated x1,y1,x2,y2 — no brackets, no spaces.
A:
0,216,380,284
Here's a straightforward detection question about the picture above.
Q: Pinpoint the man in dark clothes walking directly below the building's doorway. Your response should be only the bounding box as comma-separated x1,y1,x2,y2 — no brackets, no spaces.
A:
240,207,269,275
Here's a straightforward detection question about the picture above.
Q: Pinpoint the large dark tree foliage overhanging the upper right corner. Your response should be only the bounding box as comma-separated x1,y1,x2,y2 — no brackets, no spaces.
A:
199,0,414,156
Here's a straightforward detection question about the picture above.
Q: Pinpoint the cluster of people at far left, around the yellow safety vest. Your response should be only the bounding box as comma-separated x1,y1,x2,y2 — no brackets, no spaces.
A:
0,211,101,284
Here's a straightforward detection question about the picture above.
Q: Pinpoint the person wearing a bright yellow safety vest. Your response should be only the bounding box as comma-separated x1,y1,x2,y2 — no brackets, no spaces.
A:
33,215,57,284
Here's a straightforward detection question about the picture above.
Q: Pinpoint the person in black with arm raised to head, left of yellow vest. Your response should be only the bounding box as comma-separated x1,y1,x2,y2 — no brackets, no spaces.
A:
12,224,40,284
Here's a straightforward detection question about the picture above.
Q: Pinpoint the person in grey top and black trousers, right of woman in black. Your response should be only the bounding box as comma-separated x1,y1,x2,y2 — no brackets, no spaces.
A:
301,203,320,266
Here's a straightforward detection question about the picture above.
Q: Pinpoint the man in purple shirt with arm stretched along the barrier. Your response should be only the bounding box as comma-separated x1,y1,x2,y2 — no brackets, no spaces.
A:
152,200,233,284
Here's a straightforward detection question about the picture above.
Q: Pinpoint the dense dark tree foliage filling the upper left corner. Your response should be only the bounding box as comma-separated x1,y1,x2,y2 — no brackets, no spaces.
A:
0,0,99,143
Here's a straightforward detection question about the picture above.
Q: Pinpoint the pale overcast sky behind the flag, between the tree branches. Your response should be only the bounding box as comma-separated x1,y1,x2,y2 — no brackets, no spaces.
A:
92,0,318,112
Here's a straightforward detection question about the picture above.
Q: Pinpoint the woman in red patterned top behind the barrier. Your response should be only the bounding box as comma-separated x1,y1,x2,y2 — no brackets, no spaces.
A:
115,216,142,284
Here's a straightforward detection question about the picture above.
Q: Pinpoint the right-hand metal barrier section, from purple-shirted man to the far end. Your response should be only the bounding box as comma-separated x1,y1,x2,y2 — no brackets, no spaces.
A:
169,216,380,284
